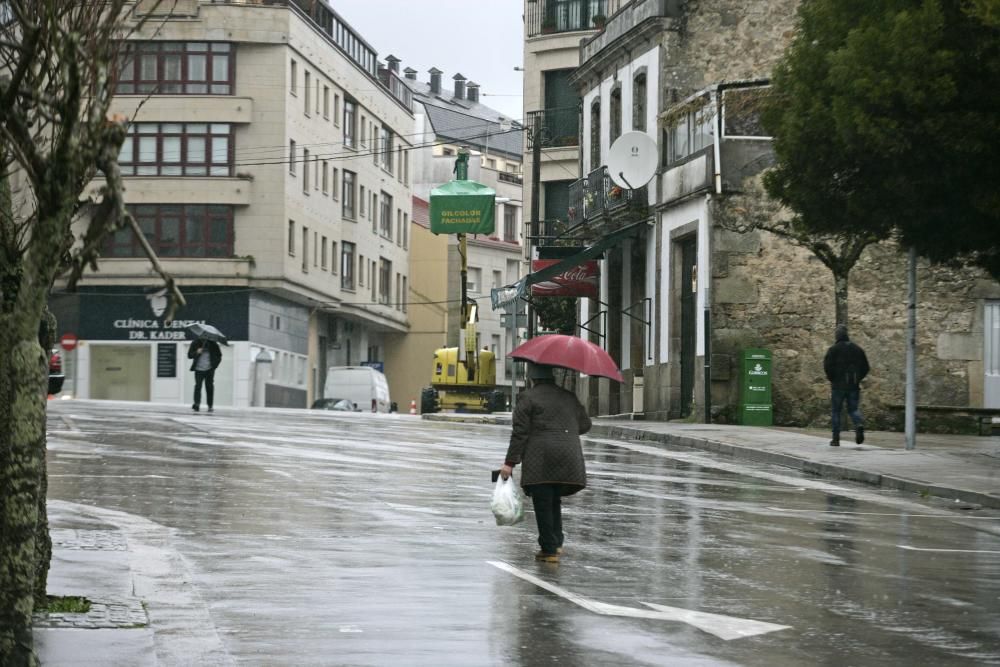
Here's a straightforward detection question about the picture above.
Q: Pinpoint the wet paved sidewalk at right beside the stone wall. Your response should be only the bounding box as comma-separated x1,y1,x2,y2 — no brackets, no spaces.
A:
423,413,1000,509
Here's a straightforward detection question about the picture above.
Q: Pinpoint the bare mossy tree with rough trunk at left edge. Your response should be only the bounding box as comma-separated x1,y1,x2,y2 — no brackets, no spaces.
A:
0,0,183,665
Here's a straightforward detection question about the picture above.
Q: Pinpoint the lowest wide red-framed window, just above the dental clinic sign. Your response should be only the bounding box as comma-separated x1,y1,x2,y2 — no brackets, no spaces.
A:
104,204,233,257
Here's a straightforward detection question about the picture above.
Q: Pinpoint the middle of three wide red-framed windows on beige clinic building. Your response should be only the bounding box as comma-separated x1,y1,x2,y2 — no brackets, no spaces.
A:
118,123,233,176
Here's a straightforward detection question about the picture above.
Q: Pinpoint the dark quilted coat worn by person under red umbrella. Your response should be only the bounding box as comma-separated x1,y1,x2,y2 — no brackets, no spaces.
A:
506,383,590,495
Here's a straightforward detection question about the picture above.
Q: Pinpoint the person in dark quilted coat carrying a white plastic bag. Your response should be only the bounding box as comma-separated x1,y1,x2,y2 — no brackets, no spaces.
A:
500,364,590,563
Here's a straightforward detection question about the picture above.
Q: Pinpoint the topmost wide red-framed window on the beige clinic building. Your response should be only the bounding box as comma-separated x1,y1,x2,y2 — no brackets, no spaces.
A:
115,42,233,95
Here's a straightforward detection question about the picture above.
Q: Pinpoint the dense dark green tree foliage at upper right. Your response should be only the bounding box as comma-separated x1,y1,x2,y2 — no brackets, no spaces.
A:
763,0,1000,278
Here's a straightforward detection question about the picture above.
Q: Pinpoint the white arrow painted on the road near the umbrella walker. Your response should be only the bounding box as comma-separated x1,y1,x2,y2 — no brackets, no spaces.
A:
486,560,792,641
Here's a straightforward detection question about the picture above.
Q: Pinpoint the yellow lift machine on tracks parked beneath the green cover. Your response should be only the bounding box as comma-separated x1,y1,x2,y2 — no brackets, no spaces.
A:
420,303,507,413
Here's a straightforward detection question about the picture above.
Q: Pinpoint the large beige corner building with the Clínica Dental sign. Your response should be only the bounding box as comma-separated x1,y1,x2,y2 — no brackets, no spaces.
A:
52,0,413,407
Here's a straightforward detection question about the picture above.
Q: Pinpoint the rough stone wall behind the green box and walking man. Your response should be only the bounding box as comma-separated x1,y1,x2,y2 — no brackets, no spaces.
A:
712,206,1000,428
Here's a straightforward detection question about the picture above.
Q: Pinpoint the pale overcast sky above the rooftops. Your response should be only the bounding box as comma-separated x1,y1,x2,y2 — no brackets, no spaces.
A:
329,0,524,120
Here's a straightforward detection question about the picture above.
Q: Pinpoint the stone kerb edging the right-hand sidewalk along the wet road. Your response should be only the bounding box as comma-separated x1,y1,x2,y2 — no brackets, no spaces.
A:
423,414,1000,509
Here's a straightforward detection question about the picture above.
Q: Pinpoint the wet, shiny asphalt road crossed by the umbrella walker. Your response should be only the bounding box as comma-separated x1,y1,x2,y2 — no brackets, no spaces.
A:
49,401,1000,666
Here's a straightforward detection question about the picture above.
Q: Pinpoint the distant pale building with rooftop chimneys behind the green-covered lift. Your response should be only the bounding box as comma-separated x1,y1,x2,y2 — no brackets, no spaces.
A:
386,65,525,404
